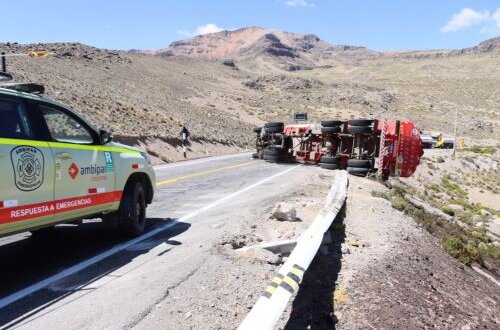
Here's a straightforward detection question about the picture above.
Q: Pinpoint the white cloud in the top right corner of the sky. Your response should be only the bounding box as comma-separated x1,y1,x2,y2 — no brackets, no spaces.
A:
441,7,500,33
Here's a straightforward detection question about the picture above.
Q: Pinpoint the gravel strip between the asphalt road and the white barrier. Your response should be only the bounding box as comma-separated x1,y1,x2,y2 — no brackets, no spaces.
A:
135,167,334,329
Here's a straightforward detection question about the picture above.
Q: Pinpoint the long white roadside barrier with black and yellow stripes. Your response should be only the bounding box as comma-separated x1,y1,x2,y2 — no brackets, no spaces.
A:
238,171,348,330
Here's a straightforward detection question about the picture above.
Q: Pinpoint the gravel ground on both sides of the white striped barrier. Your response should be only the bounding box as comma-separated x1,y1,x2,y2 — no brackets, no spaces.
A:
136,168,500,329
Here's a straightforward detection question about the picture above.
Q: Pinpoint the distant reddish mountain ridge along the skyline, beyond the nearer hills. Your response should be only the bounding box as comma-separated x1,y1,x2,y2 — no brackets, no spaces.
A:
143,26,500,60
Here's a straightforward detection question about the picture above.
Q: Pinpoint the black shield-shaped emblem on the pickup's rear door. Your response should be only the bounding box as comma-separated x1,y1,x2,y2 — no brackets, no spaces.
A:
10,146,45,191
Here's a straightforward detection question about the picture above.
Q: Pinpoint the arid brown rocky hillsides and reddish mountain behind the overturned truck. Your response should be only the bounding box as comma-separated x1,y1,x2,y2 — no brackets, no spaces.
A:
0,27,500,162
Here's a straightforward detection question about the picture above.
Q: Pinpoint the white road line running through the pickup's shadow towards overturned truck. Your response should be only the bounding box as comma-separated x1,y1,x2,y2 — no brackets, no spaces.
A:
0,165,301,309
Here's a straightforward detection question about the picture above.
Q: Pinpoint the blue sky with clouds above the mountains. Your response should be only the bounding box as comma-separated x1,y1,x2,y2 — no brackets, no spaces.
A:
0,0,500,50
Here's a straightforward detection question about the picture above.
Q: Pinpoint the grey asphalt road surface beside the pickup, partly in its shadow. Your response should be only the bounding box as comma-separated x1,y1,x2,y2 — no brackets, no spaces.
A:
0,154,309,329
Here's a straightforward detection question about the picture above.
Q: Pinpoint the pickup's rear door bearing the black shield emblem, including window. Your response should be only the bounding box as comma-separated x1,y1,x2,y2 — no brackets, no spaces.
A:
0,96,55,236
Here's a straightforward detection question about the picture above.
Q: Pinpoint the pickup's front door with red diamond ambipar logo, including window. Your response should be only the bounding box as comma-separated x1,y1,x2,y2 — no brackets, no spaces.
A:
37,104,119,220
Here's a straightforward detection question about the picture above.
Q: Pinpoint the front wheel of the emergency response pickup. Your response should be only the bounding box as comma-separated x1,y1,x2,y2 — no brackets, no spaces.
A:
119,180,146,237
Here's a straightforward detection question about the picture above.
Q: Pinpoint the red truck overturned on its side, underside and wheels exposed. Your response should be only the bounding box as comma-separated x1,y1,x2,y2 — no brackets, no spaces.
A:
253,119,423,180
